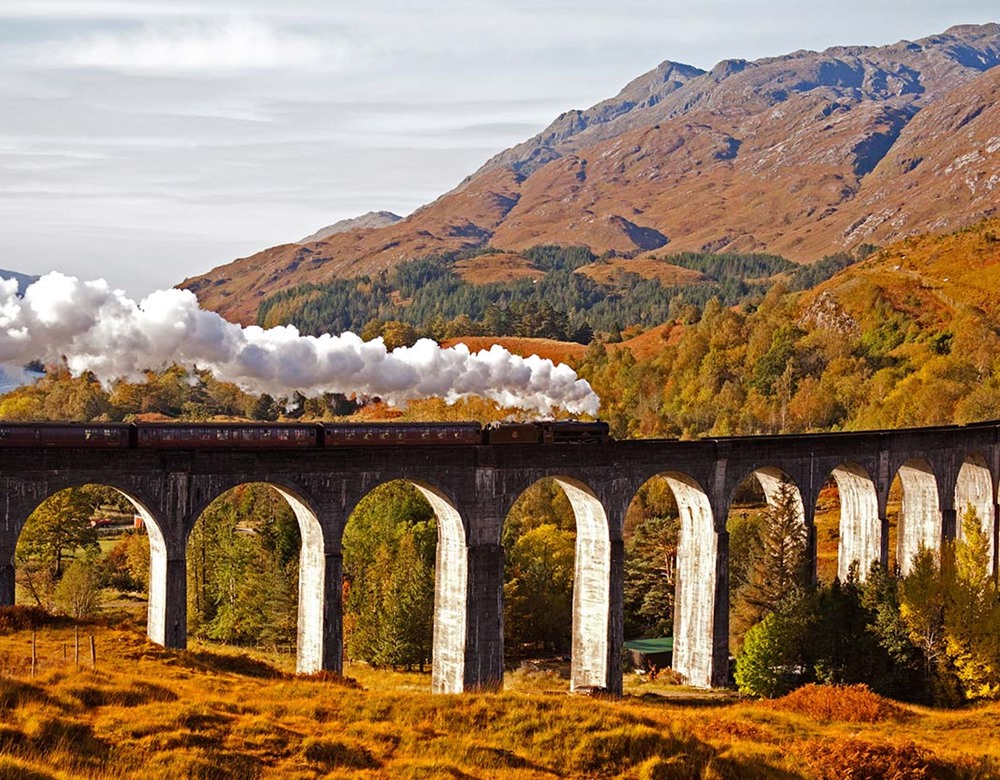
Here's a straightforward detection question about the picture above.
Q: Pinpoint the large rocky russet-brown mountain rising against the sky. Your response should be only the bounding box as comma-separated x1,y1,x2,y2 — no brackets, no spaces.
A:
181,24,1000,323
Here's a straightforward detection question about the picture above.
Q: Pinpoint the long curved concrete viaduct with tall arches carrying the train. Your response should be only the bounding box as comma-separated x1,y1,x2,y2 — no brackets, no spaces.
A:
0,422,1000,693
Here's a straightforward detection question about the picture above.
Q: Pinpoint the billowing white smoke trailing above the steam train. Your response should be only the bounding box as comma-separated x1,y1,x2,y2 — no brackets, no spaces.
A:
0,273,600,414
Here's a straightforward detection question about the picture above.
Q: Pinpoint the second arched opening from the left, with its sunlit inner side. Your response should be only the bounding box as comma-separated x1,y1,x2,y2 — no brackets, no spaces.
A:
187,482,326,674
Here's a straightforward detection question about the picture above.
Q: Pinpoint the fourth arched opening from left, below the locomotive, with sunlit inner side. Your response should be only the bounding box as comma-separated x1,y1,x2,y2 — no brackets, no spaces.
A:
503,477,613,690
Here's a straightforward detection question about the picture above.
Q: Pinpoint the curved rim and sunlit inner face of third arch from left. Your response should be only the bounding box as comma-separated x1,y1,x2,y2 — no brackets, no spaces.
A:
340,477,469,693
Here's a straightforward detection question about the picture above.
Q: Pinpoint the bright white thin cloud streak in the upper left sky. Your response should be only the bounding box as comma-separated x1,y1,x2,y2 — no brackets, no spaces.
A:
30,18,348,74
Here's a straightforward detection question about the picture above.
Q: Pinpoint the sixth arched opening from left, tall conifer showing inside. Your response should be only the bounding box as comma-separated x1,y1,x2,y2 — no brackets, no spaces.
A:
726,466,814,656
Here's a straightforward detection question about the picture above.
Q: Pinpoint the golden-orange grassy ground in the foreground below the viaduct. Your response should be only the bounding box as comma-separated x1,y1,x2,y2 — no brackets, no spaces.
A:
0,625,1000,780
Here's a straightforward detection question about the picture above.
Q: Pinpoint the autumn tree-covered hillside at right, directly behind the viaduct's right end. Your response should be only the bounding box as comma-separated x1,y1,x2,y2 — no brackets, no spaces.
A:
579,218,1000,436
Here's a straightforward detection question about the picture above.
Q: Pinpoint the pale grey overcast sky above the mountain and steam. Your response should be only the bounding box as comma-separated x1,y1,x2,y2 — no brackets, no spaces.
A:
0,0,1000,297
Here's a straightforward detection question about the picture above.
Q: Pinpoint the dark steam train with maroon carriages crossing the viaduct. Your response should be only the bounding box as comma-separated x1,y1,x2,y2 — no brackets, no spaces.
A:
0,420,609,449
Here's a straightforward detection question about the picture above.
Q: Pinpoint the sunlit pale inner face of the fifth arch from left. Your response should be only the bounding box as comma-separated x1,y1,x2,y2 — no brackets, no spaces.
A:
640,471,728,688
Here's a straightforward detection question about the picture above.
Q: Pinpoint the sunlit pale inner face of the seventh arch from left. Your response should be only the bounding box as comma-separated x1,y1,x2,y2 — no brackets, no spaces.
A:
830,462,882,580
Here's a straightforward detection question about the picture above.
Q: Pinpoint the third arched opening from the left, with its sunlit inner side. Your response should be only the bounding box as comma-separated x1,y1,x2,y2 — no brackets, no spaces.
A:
342,480,468,693
